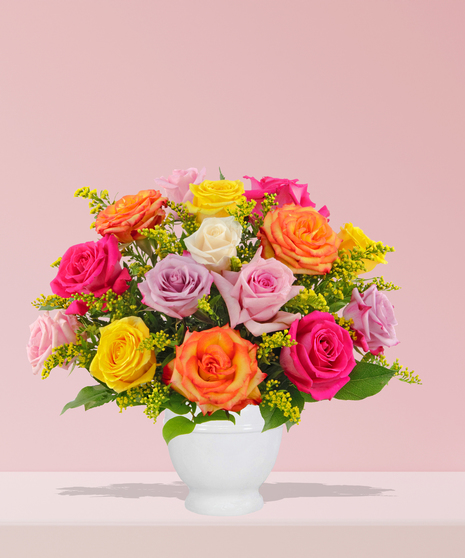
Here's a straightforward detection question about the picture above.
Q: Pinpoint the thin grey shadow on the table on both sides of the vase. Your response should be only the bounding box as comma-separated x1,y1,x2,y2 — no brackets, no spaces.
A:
57,481,394,502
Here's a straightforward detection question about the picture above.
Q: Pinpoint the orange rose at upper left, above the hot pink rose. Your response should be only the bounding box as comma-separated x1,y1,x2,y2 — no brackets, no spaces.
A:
95,190,168,242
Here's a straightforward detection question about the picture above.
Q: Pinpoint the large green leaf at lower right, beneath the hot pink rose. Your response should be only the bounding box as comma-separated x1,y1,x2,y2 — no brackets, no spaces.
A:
334,362,394,401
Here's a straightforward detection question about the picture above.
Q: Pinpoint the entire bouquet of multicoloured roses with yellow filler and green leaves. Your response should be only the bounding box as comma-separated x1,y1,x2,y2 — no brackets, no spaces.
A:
27,168,420,442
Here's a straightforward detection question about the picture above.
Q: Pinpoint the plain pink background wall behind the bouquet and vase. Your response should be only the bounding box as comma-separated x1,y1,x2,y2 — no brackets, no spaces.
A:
0,0,465,471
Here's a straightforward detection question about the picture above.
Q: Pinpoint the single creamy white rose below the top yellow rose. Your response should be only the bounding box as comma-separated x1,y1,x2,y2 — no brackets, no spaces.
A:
184,216,242,272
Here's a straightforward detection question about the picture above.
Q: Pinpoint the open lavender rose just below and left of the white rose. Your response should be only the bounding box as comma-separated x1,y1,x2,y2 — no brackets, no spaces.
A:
138,252,213,319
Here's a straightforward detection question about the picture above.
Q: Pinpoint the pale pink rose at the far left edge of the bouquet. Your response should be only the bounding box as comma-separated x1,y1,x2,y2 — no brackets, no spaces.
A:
27,310,81,374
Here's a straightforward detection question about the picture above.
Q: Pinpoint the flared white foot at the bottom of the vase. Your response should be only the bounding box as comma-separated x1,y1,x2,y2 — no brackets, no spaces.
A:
185,489,263,516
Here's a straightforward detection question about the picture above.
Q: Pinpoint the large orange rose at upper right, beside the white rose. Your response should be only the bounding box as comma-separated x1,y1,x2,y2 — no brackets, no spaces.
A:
258,204,341,275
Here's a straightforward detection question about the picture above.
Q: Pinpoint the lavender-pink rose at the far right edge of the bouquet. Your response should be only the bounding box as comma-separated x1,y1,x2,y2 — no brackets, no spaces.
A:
342,285,399,355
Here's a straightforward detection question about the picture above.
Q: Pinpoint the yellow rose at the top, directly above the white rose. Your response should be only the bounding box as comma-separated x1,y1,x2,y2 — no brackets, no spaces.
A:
185,180,244,221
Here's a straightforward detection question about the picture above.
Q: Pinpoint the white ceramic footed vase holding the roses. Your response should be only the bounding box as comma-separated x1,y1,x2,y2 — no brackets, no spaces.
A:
164,405,283,515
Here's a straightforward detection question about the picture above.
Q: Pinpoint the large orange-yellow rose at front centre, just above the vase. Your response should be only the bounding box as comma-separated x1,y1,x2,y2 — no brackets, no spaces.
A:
163,325,266,415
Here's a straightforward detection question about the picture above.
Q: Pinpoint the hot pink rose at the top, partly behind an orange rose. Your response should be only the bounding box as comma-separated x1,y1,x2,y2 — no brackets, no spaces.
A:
244,176,329,218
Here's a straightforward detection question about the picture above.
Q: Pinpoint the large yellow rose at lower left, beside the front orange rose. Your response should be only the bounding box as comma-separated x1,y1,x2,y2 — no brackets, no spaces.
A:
90,316,156,393
